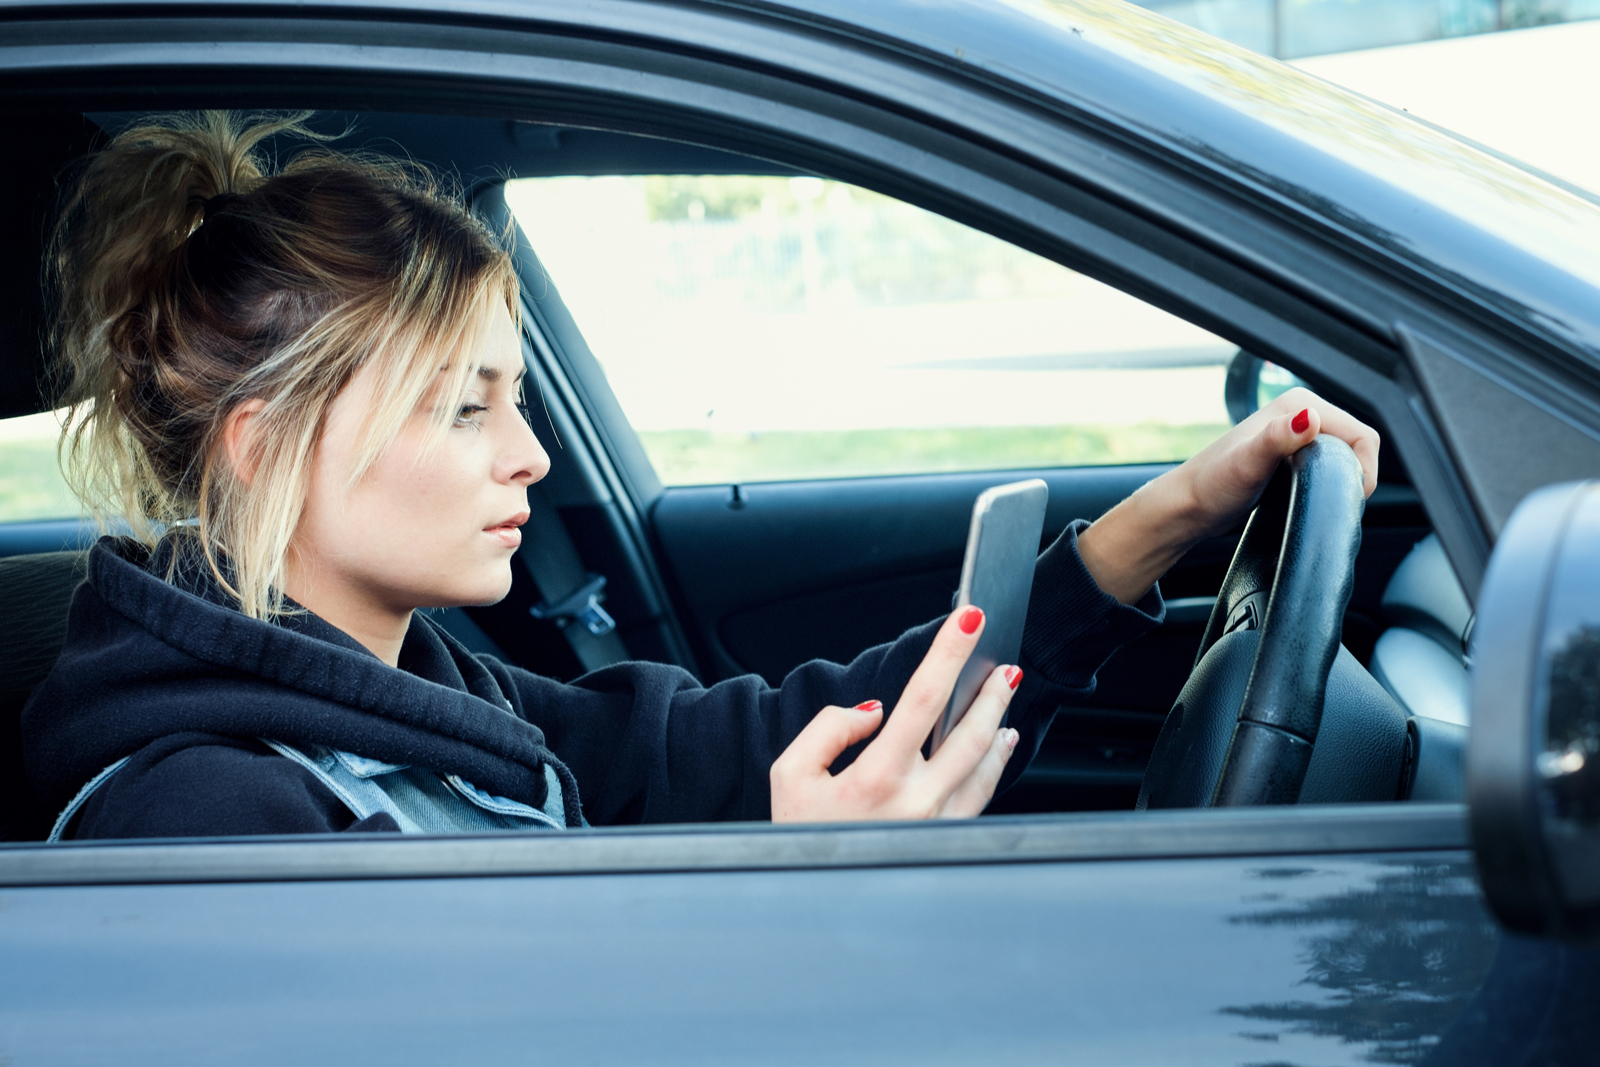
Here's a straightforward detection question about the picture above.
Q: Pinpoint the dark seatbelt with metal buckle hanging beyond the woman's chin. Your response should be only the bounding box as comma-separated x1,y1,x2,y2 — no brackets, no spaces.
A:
517,485,627,672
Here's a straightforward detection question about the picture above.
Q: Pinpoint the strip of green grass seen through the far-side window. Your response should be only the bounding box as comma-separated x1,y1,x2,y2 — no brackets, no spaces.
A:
638,424,1227,485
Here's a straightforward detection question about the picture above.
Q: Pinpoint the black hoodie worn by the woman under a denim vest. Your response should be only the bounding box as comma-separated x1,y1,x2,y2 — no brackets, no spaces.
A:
22,526,1163,838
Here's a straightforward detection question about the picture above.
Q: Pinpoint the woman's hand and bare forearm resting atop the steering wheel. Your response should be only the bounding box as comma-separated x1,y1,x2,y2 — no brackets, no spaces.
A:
1078,389,1379,603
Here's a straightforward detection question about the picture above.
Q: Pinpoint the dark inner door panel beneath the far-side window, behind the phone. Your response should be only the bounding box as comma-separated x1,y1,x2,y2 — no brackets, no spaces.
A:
651,466,1166,681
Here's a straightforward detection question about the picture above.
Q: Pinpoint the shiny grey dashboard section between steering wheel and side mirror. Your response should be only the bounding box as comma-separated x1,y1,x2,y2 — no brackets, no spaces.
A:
1371,534,1472,800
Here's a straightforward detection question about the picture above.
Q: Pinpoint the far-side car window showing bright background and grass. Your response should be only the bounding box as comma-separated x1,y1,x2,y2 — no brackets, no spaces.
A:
506,176,1235,485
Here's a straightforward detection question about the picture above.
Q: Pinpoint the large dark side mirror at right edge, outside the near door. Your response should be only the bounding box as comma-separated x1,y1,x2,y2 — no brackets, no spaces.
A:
1467,482,1600,941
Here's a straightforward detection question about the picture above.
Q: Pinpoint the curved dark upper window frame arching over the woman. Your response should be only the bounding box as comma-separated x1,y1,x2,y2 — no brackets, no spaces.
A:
0,0,1497,595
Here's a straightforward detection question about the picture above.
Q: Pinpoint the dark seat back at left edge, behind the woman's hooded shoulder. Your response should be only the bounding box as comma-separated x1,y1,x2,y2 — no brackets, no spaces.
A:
0,552,88,841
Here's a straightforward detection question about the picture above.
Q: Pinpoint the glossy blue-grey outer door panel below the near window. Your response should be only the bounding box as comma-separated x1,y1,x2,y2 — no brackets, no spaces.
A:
0,814,1498,1067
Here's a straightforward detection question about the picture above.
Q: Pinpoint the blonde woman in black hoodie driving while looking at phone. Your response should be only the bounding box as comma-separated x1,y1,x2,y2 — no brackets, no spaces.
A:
22,114,1378,838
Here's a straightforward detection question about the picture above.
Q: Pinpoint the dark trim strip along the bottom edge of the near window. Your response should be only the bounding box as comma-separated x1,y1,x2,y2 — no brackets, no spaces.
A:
0,803,1469,888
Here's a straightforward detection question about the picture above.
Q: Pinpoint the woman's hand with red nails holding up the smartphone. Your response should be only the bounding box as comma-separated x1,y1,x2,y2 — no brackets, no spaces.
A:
771,608,1022,822
